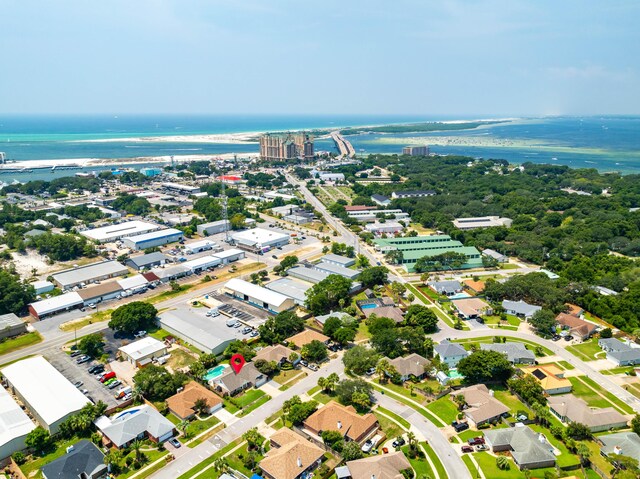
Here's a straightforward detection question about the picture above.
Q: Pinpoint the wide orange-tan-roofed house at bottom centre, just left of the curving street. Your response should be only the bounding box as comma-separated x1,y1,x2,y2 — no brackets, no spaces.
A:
304,401,378,443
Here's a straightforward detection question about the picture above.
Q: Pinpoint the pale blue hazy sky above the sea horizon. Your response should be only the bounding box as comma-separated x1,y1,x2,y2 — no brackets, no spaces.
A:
0,0,640,116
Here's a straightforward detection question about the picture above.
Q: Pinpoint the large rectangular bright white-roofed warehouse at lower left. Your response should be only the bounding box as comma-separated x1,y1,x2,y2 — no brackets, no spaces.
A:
0,356,90,434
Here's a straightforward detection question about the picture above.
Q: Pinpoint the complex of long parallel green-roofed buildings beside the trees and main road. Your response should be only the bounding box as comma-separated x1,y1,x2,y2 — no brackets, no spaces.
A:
373,235,482,272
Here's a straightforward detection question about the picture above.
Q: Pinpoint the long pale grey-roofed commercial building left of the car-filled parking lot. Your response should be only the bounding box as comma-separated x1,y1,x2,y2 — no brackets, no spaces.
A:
160,310,236,355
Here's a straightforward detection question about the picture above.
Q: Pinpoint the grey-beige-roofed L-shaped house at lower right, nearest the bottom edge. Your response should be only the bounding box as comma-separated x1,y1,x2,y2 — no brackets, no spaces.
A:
484,426,556,469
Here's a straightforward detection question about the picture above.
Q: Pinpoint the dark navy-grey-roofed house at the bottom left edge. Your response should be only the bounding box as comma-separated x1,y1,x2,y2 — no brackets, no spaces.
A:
40,439,107,479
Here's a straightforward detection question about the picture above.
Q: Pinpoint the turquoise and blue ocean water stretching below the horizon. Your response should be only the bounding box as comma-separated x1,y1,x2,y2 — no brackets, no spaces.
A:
0,115,640,181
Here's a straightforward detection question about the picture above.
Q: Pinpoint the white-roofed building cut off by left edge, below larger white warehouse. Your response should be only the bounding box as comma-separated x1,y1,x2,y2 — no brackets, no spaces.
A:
0,386,36,459
